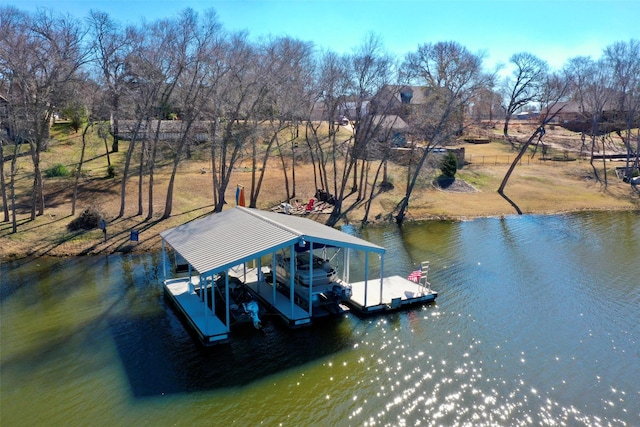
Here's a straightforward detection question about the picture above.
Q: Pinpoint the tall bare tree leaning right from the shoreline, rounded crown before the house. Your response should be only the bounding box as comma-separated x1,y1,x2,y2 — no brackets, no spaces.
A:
396,42,492,224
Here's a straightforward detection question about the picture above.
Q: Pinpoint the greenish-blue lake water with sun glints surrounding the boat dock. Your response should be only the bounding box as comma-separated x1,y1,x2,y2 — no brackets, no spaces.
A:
0,212,640,426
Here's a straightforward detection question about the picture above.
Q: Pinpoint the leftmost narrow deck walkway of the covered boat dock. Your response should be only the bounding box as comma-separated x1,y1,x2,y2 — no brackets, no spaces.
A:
164,277,229,346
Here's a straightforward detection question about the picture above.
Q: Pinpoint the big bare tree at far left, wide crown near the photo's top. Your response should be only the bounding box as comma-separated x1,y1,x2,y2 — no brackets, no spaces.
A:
0,7,87,224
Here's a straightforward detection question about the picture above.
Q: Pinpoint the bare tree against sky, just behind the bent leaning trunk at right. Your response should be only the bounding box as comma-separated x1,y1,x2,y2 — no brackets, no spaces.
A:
503,52,548,146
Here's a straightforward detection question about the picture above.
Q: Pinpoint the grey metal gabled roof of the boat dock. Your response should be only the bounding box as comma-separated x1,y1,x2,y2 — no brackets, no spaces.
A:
160,206,385,274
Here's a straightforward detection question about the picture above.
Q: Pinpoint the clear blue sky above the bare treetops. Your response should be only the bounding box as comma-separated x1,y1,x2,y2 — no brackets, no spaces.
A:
11,0,640,73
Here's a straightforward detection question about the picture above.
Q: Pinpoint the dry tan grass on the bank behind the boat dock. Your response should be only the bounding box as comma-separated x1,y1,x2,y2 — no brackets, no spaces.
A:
0,122,640,259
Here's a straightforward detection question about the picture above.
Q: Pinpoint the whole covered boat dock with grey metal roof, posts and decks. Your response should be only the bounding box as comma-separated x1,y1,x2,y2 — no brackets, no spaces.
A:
160,206,437,345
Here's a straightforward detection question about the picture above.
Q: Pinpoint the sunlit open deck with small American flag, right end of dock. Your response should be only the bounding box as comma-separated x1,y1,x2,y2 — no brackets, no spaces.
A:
347,276,438,314
